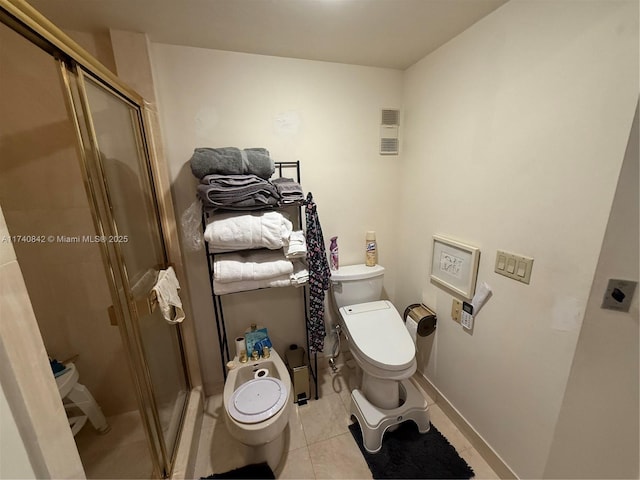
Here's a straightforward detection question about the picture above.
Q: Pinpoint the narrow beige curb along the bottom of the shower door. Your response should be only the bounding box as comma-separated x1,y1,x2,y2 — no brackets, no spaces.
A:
170,387,204,480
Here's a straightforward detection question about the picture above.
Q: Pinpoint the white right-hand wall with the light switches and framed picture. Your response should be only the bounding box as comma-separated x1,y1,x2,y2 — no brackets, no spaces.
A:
394,1,638,478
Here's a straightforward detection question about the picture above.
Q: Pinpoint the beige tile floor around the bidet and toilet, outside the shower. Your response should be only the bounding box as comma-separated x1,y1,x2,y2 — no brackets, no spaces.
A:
194,366,499,479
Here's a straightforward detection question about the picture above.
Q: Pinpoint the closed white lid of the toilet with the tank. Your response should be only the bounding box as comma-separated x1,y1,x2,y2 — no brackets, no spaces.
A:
340,300,416,371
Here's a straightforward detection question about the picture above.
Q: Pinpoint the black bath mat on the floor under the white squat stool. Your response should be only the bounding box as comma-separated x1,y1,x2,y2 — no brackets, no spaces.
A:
349,421,474,479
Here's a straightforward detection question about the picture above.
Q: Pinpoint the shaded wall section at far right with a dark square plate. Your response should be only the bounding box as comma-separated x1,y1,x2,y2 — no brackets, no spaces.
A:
544,109,640,478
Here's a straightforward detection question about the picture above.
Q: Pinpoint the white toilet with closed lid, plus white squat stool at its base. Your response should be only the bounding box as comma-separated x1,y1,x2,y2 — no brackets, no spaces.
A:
331,265,430,453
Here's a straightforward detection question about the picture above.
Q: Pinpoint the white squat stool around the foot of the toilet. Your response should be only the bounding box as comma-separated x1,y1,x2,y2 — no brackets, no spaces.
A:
351,379,431,453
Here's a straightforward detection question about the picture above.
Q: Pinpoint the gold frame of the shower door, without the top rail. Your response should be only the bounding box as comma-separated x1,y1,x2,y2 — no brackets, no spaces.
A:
60,61,189,477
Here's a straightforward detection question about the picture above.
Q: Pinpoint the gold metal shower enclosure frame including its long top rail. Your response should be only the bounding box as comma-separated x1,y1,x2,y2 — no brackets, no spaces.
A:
0,0,190,477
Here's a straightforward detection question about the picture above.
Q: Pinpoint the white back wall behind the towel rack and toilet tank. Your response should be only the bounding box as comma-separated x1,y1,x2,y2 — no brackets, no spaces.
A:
151,44,402,392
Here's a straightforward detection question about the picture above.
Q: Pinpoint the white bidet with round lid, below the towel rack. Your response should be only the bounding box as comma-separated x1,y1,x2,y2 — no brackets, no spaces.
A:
223,349,293,472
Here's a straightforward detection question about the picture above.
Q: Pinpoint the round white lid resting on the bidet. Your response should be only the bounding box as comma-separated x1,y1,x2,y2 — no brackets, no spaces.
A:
229,377,288,423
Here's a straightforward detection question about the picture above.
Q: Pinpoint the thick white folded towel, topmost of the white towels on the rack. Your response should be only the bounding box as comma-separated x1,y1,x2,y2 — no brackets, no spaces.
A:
204,211,293,252
